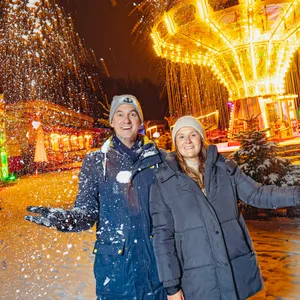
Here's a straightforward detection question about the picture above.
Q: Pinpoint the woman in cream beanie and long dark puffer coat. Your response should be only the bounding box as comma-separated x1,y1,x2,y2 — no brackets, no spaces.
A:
150,116,300,300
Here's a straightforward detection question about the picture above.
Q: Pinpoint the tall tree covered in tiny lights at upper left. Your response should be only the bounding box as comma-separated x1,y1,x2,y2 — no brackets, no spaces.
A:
0,0,101,113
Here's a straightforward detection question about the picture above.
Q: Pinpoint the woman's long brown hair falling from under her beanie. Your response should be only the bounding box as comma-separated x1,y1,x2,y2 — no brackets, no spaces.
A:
174,137,209,189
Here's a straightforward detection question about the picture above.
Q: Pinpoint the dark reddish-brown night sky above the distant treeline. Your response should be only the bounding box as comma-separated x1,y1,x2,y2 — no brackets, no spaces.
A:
58,0,158,81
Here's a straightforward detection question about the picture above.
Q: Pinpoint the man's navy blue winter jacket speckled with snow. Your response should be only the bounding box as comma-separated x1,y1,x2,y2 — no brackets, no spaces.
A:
74,137,165,300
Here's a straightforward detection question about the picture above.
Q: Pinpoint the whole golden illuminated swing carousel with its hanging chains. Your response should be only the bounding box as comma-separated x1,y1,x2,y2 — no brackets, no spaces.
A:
152,0,300,138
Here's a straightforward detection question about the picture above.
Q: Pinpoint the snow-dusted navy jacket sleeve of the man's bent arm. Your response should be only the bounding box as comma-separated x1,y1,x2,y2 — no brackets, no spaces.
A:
57,154,99,231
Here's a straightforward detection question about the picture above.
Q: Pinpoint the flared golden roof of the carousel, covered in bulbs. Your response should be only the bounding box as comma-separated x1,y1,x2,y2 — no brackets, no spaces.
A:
152,0,300,99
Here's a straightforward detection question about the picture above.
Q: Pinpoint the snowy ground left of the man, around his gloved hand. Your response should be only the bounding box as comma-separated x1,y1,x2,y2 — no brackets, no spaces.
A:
0,170,95,300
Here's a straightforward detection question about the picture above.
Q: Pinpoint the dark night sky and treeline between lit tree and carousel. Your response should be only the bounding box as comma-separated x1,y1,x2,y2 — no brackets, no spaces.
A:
57,0,168,120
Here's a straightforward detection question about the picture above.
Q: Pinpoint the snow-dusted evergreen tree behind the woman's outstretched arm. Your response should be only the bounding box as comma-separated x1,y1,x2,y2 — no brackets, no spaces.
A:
232,115,299,186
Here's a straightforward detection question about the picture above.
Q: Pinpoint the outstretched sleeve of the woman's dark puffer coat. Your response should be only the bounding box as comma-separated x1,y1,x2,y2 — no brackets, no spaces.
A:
229,161,300,209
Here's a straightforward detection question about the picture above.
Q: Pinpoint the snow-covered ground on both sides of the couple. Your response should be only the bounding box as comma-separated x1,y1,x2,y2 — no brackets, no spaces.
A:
0,170,300,300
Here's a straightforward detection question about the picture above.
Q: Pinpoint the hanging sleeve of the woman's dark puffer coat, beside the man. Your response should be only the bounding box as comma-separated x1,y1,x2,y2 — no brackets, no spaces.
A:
150,184,182,288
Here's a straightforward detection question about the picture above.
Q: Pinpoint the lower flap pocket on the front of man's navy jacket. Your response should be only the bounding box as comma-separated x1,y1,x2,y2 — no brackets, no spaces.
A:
93,240,126,294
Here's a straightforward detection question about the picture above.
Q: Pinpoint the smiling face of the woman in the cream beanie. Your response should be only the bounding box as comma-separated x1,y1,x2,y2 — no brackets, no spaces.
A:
175,127,202,161
